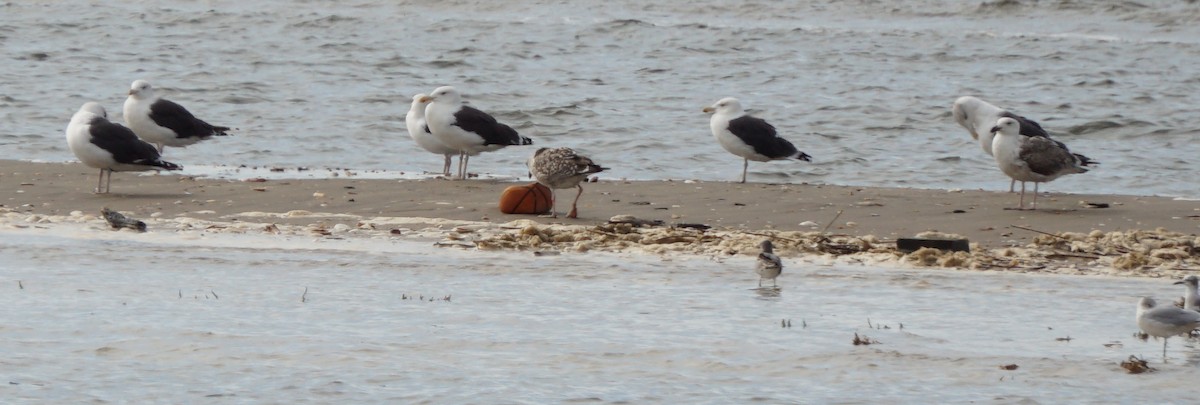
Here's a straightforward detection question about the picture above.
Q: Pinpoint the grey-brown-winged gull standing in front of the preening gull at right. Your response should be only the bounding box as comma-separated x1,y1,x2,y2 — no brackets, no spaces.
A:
990,117,1087,210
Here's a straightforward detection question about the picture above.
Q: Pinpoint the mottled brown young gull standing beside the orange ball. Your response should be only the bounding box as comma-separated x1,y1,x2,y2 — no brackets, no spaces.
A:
528,147,608,218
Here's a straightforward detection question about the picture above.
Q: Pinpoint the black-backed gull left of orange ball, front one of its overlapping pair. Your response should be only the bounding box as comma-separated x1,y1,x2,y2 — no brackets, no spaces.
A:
421,86,533,179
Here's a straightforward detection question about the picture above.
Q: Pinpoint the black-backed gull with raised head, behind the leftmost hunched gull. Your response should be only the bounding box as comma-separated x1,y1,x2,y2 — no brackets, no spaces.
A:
125,80,229,153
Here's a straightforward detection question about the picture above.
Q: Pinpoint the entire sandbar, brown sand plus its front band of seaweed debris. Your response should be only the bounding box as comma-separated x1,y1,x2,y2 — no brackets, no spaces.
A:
0,161,1200,276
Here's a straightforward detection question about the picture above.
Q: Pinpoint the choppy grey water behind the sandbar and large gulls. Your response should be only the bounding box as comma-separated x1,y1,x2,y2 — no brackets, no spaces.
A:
0,0,1200,198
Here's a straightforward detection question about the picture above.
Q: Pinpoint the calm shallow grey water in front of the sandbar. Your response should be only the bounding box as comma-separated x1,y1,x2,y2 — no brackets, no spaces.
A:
0,224,1200,404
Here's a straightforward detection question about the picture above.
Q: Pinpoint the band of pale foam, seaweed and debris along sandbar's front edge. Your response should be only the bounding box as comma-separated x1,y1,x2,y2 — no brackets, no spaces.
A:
7,207,1200,278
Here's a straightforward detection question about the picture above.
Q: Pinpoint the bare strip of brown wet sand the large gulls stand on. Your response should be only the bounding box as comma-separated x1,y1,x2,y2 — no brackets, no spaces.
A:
0,161,1200,248
